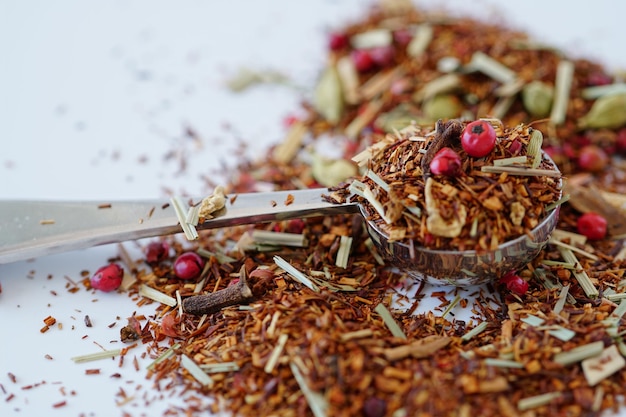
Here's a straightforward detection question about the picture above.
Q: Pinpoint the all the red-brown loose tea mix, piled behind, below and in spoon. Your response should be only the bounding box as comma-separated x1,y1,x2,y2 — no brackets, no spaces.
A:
62,1,626,417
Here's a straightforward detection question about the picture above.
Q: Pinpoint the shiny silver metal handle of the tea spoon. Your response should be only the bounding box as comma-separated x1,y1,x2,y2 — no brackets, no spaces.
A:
0,188,358,264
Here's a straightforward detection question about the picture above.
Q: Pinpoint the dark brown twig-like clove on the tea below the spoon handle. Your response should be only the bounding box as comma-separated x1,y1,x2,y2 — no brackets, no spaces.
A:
183,266,252,316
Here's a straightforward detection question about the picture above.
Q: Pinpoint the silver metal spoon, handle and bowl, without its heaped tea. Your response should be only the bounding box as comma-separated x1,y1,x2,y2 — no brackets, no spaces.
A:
0,189,558,285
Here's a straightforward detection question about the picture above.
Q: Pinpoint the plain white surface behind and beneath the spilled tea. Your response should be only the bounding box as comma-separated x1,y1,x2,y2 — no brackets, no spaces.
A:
0,0,626,416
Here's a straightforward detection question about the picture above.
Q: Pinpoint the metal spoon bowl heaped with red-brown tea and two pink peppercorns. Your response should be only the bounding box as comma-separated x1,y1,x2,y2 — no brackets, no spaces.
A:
326,119,562,285
